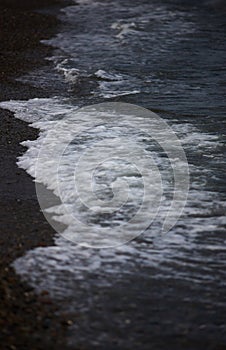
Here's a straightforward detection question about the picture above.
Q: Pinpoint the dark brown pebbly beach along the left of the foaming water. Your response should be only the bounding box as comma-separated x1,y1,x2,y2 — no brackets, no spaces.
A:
0,0,72,350
